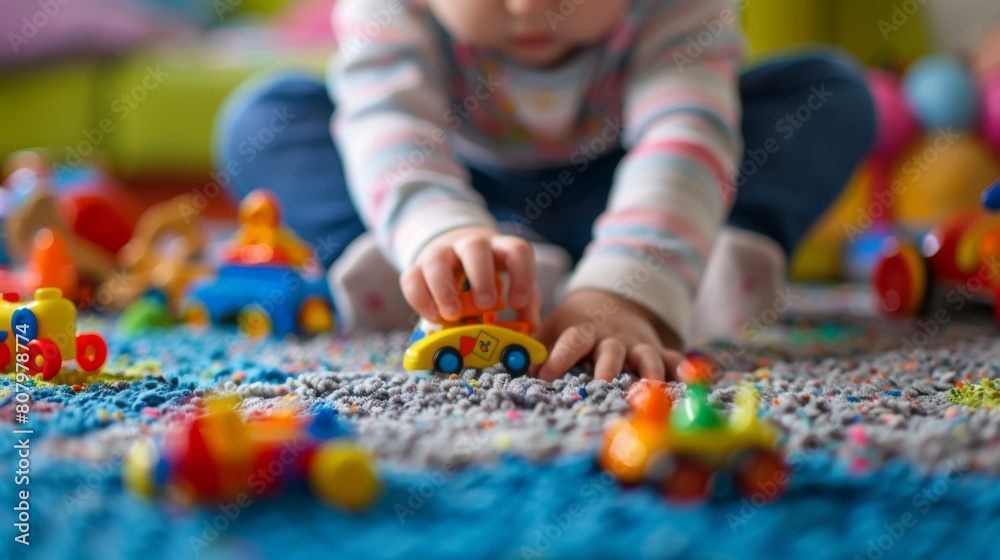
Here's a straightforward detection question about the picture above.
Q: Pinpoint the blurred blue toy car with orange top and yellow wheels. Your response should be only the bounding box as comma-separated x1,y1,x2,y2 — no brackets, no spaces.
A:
181,189,335,337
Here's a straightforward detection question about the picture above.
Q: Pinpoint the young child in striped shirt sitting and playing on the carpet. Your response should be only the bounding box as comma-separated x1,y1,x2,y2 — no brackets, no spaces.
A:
217,0,875,380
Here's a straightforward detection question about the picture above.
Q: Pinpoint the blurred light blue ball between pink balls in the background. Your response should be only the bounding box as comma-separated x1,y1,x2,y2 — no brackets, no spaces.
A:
903,55,979,131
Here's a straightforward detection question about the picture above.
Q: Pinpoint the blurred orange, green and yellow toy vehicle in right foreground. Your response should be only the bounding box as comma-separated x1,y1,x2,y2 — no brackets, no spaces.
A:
598,356,790,504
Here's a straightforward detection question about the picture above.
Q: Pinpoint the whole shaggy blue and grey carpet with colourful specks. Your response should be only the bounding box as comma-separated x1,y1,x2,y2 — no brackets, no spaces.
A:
0,287,1000,560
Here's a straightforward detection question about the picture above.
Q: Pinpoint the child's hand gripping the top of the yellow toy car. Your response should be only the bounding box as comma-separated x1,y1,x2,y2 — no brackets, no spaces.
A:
400,228,541,329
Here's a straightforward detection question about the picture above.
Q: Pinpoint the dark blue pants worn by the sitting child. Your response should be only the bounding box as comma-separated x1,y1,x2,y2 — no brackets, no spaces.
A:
215,52,875,265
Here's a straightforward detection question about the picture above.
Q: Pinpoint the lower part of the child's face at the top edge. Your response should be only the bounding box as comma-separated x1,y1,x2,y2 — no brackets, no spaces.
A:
426,0,630,67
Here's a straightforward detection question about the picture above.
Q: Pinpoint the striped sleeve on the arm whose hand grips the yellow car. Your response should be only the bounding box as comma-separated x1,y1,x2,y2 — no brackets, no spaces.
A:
329,0,496,269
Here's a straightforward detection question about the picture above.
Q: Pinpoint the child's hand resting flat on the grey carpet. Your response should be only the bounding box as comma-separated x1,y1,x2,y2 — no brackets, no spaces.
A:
538,290,683,381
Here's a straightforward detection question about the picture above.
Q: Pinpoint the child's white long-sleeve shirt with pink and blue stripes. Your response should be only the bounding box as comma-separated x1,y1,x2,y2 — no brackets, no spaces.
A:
329,0,743,337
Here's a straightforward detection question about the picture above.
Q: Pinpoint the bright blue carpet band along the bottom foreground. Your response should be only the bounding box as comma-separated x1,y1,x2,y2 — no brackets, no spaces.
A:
0,450,1000,560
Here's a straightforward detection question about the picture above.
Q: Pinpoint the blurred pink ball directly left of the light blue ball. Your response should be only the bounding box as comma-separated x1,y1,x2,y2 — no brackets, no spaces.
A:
868,70,917,157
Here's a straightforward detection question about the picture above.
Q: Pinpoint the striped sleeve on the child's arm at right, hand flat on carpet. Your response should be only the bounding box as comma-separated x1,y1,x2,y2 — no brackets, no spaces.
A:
567,0,744,346
